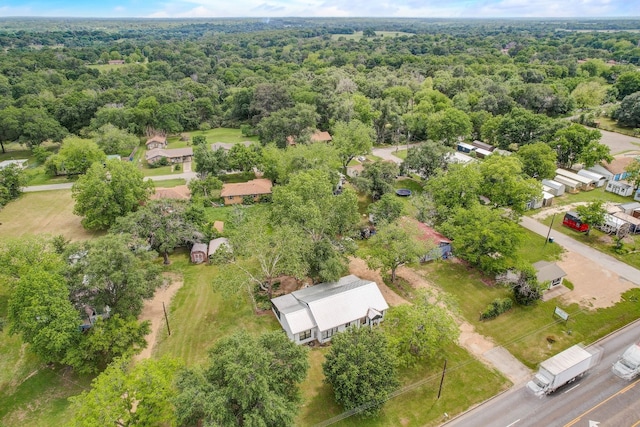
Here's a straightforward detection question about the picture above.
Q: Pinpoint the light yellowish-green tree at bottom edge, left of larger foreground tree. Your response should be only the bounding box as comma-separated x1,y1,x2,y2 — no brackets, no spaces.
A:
70,358,182,427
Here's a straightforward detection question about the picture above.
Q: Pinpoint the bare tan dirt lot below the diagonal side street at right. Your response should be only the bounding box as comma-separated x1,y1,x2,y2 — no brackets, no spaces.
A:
558,251,635,309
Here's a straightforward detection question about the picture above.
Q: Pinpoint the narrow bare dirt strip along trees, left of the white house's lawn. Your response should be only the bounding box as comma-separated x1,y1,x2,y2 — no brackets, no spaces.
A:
133,273,184,361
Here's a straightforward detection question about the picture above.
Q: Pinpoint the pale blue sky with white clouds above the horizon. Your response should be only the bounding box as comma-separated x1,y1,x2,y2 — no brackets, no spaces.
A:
0,0,640,18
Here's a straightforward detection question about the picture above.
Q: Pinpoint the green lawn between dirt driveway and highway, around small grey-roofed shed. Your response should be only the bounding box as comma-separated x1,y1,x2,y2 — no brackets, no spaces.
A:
419,262,640,368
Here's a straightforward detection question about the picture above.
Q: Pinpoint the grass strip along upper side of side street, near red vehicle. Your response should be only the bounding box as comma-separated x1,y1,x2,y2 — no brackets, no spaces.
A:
541,214,640,269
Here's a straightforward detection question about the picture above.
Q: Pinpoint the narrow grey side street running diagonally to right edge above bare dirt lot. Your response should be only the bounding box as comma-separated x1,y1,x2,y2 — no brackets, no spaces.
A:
520,216,640,286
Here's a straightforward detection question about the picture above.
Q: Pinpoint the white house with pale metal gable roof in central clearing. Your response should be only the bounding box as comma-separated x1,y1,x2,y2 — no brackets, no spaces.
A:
271,275,389,344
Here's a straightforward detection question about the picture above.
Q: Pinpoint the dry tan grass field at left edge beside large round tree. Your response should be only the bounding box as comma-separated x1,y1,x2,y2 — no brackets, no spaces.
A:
0,190,100,241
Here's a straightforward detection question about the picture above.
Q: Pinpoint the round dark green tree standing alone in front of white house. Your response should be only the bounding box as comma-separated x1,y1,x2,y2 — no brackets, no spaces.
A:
322,327,399,417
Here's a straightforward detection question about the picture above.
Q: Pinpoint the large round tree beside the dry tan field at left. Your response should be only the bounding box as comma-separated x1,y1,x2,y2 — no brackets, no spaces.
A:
71,160,153,230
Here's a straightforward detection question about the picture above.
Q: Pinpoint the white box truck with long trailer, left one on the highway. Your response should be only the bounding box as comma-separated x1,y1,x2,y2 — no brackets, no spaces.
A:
527,345,599,396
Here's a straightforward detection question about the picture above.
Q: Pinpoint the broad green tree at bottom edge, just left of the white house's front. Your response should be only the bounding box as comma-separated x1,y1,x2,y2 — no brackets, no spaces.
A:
174,331,309,427
